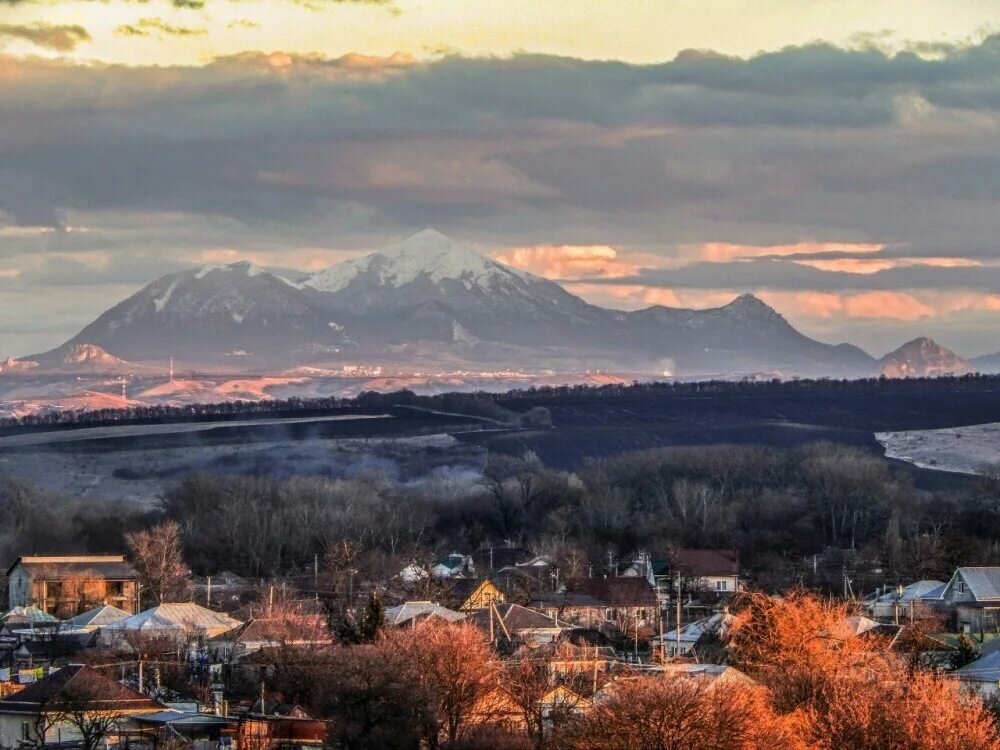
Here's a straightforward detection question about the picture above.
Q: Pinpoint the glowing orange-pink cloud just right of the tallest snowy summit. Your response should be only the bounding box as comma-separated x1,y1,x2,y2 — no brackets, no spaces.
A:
493,245,659,279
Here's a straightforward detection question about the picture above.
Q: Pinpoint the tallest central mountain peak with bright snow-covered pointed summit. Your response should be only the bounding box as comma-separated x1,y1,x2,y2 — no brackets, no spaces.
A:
301,229,615,346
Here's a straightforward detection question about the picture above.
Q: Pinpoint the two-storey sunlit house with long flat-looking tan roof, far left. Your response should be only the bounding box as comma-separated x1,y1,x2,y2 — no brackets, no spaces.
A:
7,555,139,615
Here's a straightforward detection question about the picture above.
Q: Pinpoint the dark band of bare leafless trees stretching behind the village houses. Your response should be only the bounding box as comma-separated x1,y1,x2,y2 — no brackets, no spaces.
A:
0,443,1000,590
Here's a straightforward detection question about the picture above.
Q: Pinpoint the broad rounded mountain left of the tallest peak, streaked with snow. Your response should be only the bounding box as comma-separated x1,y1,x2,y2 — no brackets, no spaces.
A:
44,262,343,361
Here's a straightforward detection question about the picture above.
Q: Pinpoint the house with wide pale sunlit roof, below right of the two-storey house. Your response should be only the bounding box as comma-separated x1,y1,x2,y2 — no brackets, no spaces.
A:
98,603,243,647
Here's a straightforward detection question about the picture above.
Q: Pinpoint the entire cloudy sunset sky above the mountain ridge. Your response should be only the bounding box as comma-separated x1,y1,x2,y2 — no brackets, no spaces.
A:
0,0,1000,356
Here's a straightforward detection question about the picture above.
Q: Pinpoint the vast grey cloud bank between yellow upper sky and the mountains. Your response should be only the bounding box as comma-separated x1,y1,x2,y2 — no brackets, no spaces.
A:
0,39,1000,356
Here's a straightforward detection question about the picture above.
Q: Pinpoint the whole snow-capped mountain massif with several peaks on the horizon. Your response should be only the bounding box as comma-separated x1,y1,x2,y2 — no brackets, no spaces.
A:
23,230,875,376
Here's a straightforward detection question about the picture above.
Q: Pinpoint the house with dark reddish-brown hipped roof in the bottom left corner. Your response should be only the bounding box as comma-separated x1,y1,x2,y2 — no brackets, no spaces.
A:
0,664,166,748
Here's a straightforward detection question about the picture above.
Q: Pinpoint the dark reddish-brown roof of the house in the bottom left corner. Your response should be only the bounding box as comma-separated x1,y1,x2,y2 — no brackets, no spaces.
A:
0,664,166,713
